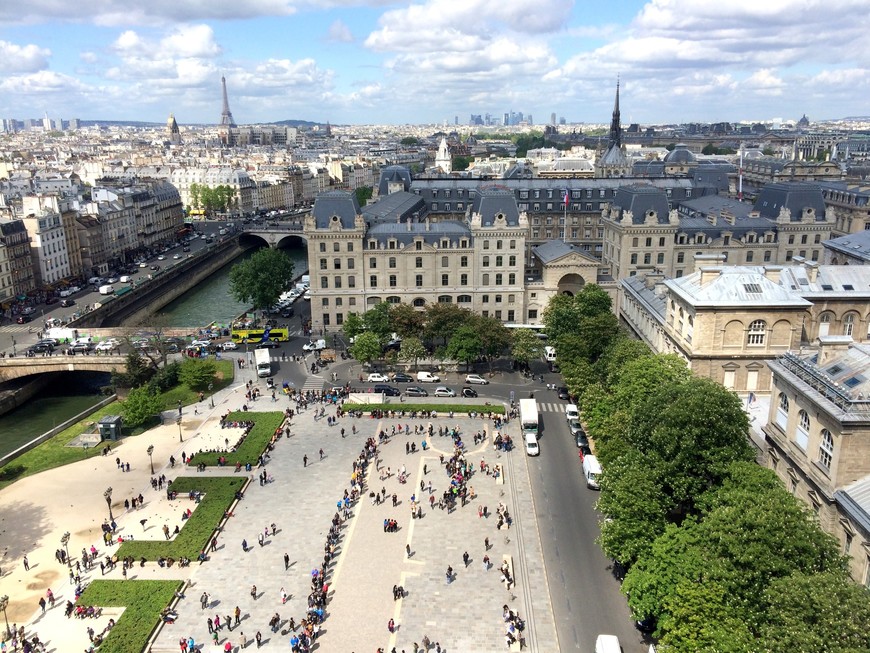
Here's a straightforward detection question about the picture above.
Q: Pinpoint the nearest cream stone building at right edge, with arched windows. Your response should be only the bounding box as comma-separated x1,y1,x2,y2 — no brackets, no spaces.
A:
763,335,870,586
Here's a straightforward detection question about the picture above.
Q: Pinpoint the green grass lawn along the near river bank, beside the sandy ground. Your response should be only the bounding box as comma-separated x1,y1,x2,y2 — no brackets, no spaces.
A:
0,360,237,489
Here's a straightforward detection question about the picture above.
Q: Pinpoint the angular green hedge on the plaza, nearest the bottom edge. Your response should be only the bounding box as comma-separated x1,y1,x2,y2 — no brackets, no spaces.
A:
76,580,183,653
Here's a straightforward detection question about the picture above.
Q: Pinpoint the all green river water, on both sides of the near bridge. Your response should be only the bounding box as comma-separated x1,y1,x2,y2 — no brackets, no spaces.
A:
0,241,308,455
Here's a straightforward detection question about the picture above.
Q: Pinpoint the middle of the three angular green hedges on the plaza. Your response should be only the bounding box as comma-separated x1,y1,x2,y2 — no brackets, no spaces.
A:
117,476,247,562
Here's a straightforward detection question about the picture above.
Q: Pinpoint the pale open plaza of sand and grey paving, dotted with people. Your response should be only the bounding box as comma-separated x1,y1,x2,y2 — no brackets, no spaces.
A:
0,364,558,653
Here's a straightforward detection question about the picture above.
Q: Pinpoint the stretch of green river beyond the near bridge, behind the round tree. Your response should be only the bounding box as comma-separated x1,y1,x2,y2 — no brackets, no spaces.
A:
160,244,308,328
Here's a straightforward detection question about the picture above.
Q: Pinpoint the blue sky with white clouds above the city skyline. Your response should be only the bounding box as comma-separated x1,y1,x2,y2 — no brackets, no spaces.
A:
0,0,870,125
